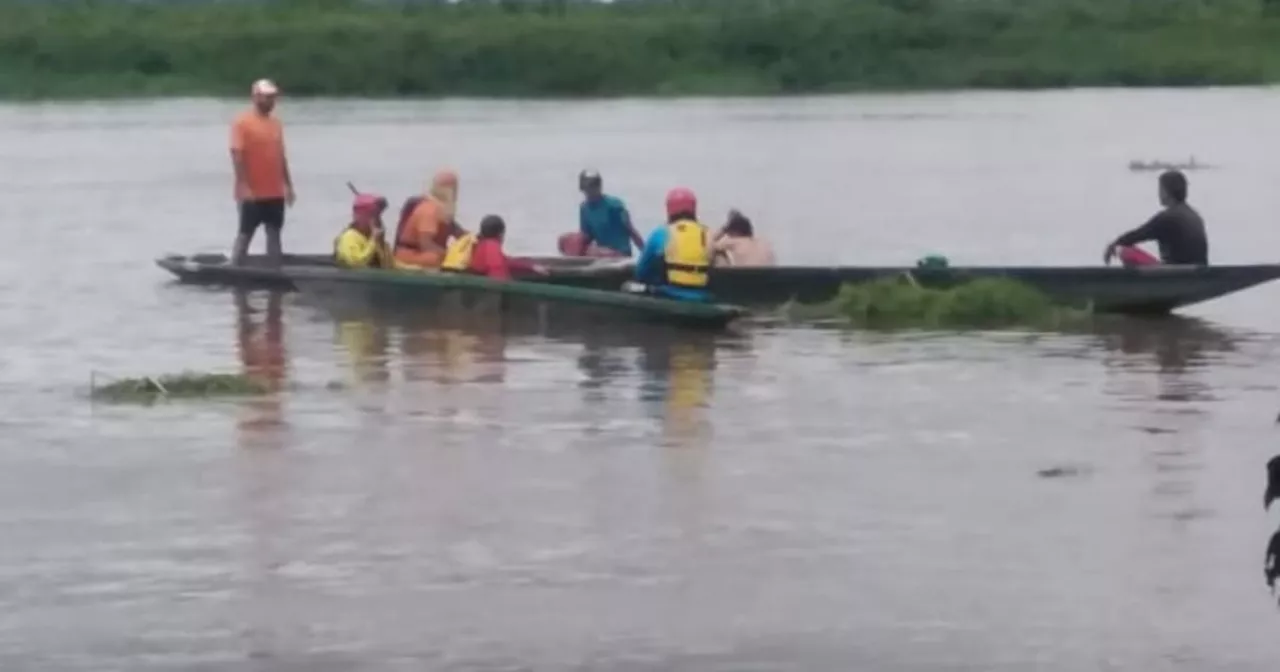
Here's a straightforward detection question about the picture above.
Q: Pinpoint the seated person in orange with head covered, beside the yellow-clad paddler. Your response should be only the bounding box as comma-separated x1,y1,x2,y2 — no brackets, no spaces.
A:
394,170,466,270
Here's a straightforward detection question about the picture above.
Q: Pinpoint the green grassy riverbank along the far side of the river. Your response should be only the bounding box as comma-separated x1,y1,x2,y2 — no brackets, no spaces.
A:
0,0,1280,97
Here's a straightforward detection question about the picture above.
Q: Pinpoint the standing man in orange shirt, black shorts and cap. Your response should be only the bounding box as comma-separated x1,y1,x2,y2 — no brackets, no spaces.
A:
232,79,294,266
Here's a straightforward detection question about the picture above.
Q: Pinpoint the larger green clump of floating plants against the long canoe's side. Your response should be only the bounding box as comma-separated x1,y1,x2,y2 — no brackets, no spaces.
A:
829,276,1085,329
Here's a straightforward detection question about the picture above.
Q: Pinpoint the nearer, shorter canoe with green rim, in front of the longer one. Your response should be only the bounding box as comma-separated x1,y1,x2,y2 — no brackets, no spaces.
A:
285,268,746,329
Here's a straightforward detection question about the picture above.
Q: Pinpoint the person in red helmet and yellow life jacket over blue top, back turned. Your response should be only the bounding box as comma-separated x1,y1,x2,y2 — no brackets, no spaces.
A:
635,187,712,301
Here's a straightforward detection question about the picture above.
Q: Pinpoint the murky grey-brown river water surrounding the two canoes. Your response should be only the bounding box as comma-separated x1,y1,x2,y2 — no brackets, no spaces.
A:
0,90,1280,672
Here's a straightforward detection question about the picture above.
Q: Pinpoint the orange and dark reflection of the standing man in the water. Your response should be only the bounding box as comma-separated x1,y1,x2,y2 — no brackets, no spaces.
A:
232,291,288,445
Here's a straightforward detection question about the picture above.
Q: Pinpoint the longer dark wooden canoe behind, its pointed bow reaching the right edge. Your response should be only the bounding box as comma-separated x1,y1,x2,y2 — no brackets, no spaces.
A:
156,255,1280,315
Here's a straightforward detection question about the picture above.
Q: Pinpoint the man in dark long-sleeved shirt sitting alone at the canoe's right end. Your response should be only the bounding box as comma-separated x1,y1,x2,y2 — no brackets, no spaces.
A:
1102,170,1208,266
